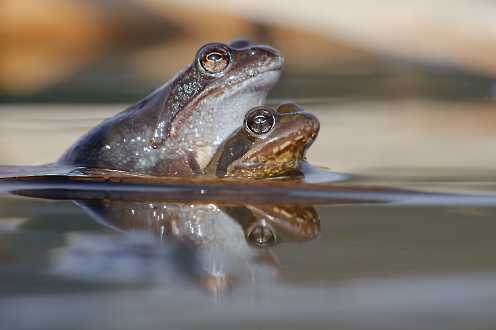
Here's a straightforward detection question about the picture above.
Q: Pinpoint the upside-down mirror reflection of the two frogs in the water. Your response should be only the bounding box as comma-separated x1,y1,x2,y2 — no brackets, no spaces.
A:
78,201,320,291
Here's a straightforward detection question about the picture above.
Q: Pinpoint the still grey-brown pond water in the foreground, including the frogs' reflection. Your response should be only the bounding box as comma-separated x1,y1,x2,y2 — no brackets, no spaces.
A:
0,161,496,329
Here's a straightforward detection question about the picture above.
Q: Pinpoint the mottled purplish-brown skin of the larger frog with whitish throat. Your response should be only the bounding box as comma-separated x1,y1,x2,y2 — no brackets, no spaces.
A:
58,41,283,176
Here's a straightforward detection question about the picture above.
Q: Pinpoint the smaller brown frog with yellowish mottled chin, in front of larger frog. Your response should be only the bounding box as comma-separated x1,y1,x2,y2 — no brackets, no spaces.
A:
206,103,320,178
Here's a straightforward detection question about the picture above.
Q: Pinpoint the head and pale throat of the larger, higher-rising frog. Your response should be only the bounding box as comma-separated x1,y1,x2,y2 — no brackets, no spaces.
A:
152,40,284,166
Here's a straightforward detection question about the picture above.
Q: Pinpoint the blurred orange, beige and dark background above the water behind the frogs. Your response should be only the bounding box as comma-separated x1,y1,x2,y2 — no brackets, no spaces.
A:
0,0,496,175
